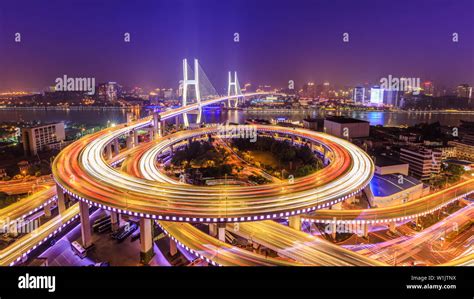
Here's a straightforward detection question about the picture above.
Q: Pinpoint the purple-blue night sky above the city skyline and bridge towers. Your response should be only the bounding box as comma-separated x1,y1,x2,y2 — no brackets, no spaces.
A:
0,0,474,91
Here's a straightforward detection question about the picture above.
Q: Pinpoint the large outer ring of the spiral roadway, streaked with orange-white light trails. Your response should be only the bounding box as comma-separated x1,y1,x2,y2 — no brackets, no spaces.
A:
53,92,373,222
